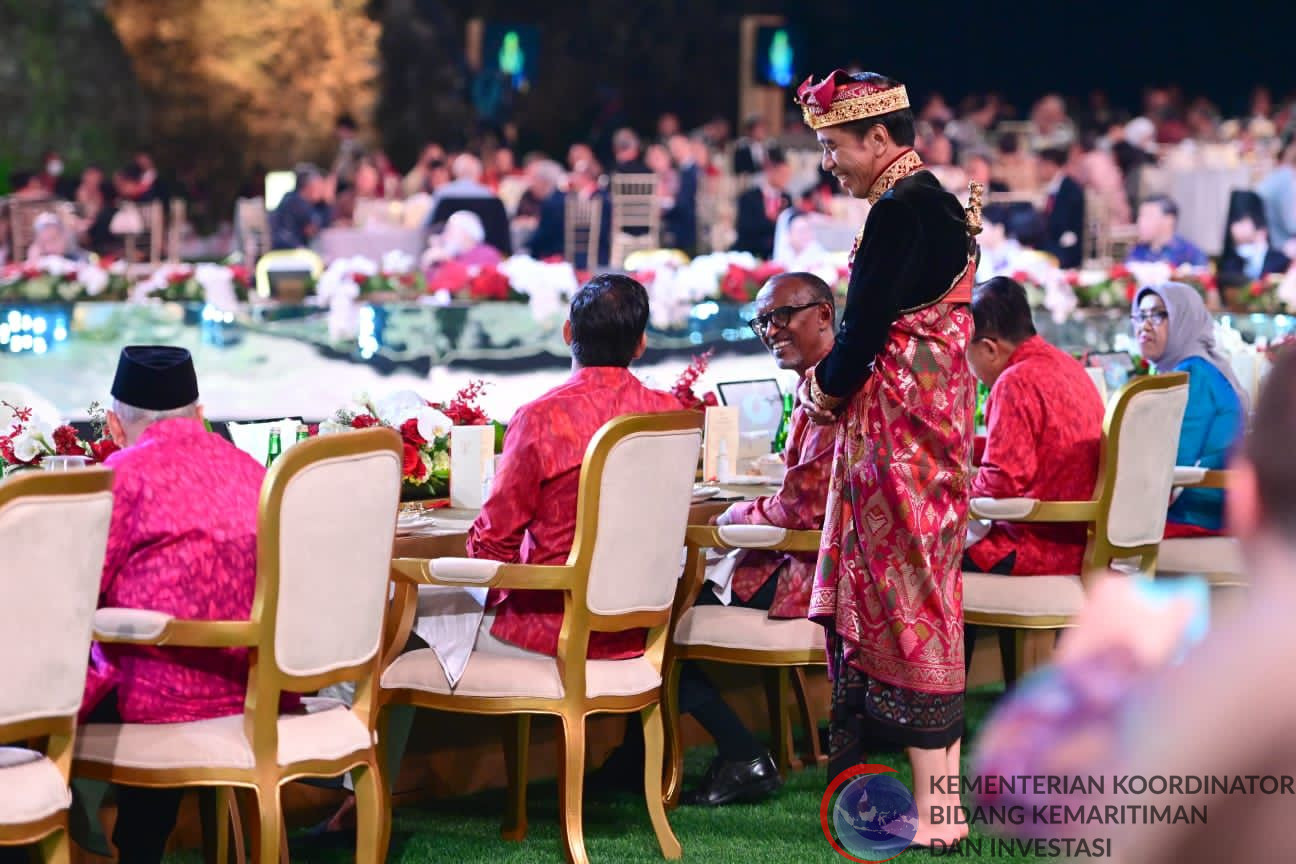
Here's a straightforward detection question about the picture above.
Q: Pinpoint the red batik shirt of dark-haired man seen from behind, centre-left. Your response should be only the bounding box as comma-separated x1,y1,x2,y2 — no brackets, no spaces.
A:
468,367,680,659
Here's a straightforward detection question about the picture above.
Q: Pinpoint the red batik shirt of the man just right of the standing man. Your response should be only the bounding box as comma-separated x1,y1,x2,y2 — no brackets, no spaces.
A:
967,335,1105,575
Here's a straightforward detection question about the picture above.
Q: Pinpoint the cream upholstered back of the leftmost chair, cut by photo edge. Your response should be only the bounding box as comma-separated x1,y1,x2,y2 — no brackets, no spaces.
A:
0,469,113,727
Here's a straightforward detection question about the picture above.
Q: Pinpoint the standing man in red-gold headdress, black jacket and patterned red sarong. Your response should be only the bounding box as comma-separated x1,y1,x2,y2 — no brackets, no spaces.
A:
797,71,980,846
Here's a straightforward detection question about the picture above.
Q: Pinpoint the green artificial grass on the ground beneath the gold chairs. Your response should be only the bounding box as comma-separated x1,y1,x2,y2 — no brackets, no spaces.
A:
167,687,1023,864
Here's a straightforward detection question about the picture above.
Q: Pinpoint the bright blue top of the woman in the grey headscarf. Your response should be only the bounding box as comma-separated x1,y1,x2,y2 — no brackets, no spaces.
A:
1166,358,1244,531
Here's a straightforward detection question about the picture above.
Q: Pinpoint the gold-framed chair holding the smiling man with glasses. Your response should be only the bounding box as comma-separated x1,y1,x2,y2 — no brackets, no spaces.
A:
662,525,827,806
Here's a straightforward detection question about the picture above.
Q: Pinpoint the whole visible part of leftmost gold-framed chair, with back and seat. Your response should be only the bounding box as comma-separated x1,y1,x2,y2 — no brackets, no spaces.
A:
0,469,113,864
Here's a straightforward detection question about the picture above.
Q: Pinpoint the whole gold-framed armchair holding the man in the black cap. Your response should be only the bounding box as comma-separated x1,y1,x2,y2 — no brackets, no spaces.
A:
74,429,402,864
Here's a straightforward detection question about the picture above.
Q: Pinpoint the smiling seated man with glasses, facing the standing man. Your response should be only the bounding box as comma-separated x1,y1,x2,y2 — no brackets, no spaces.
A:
601,273,835,806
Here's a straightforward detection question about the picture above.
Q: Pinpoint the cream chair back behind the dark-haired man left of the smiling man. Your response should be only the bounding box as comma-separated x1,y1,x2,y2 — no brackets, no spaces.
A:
573,412,701,615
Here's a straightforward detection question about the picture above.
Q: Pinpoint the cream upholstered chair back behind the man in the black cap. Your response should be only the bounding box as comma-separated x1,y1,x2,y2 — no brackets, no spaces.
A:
258,429,400,677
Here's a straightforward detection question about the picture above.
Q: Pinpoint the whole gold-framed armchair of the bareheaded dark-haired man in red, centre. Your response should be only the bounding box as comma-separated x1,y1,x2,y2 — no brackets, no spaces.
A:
381,411,702,864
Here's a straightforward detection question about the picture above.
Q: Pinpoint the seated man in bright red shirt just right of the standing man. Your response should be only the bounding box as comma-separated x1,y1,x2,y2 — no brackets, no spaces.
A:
963,276,1105,577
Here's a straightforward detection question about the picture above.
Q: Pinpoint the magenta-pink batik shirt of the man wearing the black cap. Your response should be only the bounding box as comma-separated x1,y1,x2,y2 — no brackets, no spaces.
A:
82,418,266,723
